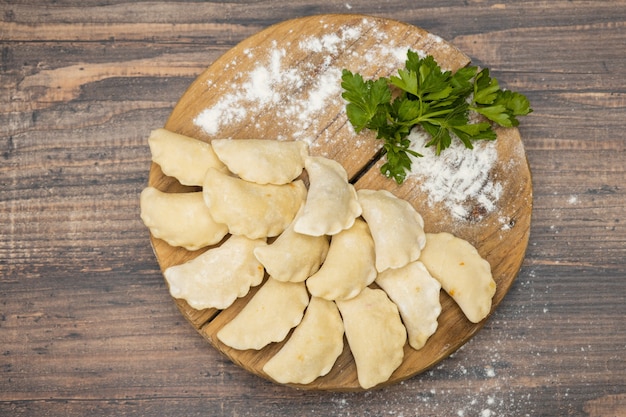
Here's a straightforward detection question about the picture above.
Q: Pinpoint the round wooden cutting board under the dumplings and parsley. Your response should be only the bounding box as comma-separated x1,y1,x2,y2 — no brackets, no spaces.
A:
149,15,532,391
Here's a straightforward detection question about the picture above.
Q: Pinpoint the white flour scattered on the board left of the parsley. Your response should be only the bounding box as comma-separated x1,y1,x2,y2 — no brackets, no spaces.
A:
194,19,409,144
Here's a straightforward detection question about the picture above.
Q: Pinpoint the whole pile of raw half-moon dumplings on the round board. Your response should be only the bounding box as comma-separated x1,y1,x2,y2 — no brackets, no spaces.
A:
140,129,496,389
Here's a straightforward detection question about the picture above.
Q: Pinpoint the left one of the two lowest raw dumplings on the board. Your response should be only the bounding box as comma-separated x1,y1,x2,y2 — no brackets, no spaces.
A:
263,297,343,384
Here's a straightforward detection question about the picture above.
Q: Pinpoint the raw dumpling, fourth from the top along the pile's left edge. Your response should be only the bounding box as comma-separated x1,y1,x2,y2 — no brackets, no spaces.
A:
217,277,309,350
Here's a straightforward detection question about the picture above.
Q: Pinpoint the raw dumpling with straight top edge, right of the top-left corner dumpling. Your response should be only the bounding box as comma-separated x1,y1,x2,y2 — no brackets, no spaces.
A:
211,139,309,184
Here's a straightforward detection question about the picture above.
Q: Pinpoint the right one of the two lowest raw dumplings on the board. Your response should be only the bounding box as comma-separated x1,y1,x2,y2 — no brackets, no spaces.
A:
337,287,406,389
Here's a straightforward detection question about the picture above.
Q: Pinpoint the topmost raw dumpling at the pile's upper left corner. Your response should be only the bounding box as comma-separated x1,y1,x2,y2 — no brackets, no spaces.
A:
148,129,226,185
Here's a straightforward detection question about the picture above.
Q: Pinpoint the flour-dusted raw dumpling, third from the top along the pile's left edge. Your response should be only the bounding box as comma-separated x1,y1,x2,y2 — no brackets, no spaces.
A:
163,236,266,310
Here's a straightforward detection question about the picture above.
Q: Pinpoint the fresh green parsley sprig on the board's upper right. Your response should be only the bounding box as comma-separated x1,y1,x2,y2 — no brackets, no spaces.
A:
341,50,532,184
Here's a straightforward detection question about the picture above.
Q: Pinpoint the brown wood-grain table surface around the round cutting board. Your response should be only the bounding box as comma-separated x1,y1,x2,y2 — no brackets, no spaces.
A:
0,0,626,417
